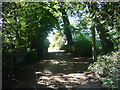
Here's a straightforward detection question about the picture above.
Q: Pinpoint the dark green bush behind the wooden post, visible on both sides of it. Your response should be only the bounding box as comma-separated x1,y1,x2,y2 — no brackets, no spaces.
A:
61,34,101,57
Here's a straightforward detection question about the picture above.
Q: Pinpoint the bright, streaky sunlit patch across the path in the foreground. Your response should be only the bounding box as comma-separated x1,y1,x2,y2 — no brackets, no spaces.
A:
37,73,87,89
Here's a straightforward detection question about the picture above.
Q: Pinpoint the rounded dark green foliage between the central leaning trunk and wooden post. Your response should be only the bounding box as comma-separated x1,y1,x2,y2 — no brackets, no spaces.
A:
72,35,92,57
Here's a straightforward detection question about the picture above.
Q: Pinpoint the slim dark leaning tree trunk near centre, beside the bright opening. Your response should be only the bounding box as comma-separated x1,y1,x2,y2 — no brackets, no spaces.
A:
59,2,73,45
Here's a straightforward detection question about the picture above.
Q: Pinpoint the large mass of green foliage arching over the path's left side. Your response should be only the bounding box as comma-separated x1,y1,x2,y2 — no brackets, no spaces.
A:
2,2,57,79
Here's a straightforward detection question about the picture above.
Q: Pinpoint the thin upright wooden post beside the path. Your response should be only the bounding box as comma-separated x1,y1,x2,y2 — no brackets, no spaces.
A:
91,26,97,60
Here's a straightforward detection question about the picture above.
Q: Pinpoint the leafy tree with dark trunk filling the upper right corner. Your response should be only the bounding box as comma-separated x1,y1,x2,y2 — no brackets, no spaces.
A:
86,2,120,54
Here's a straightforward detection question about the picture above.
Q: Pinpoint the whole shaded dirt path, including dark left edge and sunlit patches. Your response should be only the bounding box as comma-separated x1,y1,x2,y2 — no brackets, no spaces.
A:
3,52,101,89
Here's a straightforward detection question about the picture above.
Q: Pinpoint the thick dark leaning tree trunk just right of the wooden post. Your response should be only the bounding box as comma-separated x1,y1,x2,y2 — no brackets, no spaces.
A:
88,3,114,53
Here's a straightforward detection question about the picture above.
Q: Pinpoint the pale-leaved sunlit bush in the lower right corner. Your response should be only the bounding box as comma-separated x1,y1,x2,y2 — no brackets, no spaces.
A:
88,52,119,88
